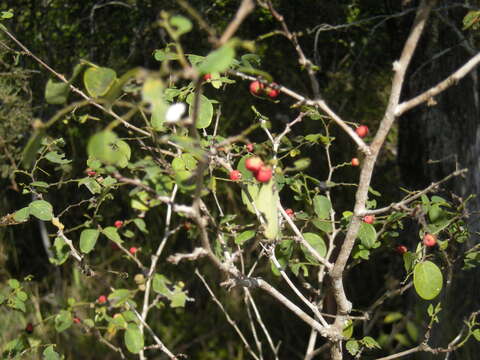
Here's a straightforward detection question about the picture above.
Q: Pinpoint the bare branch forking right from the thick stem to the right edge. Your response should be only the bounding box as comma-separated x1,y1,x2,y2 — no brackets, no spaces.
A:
395,53,480,117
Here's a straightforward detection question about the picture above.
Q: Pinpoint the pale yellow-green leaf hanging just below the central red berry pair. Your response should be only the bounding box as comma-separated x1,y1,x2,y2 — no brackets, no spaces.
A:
255,180,279,240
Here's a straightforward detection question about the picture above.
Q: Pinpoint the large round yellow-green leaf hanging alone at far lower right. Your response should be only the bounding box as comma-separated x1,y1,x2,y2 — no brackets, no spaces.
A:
413,261,443,300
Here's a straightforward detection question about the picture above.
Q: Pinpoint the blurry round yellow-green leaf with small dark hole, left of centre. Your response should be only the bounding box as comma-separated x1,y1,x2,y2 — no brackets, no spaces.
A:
87,130,131,167
